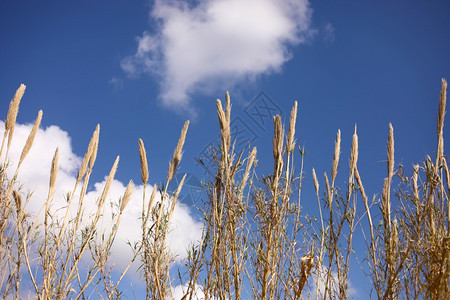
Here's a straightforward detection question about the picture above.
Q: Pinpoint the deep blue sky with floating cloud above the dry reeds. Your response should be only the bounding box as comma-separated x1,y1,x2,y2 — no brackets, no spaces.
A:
0,0,450,292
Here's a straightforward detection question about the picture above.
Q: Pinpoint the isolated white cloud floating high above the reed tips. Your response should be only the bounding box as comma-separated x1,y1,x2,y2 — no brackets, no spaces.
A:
121,0,314,111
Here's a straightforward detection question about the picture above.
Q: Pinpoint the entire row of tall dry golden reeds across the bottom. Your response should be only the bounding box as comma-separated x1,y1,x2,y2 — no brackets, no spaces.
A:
0,80,450,299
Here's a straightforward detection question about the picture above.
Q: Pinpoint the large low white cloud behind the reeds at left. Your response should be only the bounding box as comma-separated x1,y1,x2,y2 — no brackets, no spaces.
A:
0,121,202,269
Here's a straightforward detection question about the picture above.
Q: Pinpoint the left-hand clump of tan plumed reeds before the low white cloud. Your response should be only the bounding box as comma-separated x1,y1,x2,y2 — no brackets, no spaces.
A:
0,84,189,299
